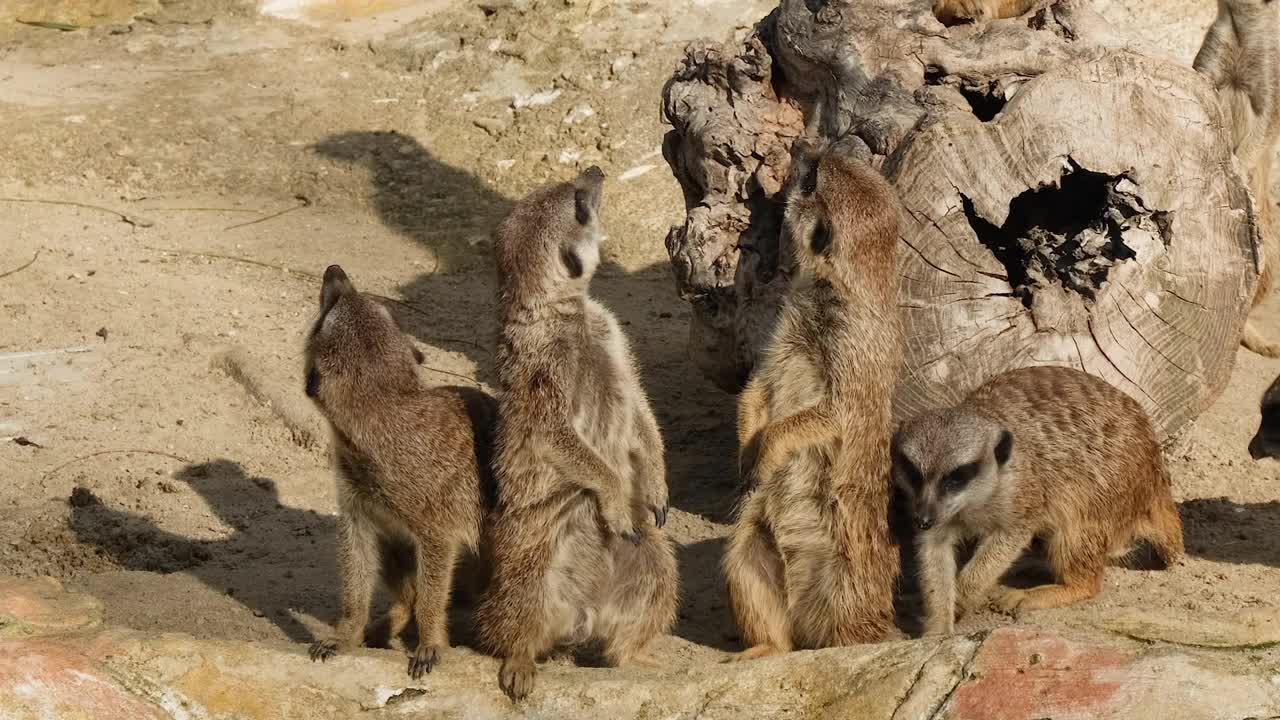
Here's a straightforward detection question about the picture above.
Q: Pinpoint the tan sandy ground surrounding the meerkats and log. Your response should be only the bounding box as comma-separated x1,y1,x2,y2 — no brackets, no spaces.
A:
0,0,1280,666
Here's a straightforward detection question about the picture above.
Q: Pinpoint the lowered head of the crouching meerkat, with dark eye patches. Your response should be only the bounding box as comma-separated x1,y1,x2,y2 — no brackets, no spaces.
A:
892,410,1014,530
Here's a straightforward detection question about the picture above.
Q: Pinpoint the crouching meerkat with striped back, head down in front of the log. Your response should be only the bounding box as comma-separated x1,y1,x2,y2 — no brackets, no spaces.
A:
893,366,1183,634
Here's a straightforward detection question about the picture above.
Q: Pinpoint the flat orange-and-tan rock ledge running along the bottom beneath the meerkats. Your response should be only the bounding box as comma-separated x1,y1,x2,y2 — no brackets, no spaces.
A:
0,578,1280,720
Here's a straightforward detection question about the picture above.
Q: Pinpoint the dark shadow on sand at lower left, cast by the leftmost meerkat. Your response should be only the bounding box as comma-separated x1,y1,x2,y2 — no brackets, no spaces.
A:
70,459,472,647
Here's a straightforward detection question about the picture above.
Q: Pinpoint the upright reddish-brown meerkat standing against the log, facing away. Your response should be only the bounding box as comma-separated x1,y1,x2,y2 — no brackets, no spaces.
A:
723,137,902,661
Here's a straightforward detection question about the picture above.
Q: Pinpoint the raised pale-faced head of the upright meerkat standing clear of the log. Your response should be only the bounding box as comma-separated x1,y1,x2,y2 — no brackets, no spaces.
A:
494,165,604,309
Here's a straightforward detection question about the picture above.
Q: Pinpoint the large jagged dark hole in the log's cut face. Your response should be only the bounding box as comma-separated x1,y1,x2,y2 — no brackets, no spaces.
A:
960,164,1171,309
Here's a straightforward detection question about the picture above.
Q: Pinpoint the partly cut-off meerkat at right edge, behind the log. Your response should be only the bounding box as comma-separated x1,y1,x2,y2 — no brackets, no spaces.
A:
1194,0,1280,357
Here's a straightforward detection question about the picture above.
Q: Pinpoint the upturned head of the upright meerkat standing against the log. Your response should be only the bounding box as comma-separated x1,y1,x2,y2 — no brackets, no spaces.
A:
782,138,899,285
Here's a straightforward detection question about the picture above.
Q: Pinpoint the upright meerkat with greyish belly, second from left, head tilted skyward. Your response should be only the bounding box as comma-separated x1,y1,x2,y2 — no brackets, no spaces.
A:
476,167,677,700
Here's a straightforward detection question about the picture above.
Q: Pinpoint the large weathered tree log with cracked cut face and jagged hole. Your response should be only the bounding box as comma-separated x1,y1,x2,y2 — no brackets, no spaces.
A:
663,0,1258,437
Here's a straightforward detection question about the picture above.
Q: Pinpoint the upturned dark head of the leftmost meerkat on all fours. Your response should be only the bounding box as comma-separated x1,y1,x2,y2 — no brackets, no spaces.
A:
305,265,422,409
